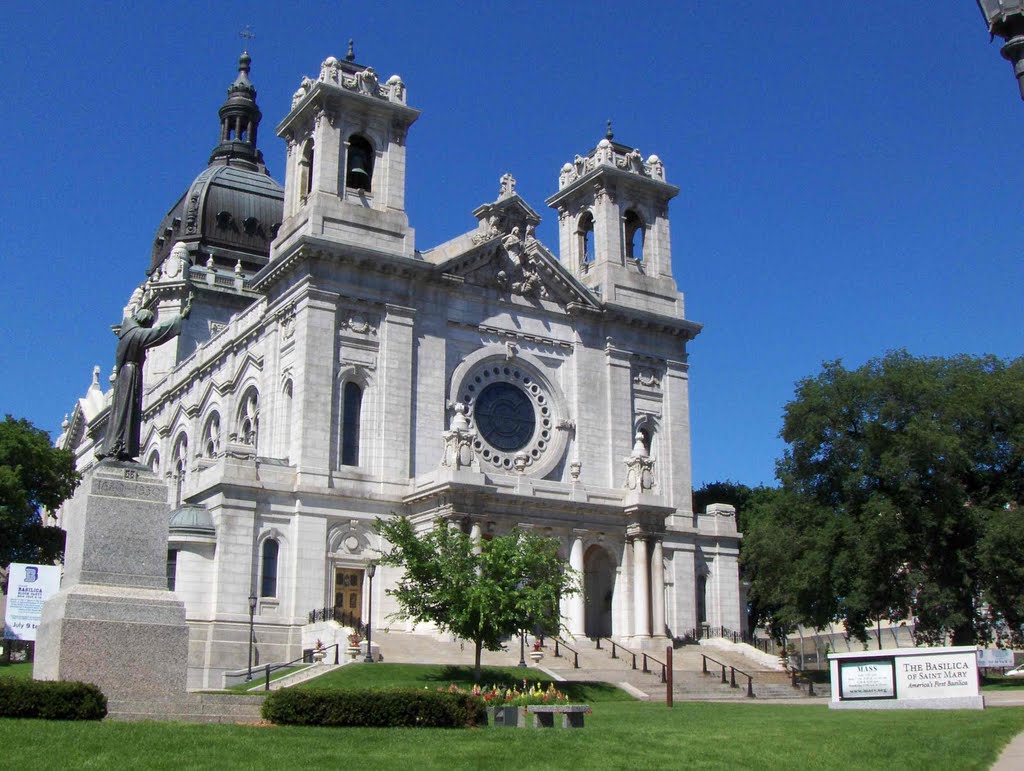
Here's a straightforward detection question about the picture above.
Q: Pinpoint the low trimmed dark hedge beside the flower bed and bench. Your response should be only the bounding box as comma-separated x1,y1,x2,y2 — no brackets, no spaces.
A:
262,688,486,728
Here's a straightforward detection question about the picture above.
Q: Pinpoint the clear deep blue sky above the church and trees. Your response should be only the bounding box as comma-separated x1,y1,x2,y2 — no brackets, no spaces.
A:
0,0,1024,485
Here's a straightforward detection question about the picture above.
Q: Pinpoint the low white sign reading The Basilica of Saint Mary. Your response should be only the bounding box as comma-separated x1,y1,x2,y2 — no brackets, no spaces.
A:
828,646,984,710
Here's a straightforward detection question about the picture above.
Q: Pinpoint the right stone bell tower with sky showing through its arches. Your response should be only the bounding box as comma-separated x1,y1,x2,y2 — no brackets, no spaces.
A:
547,122,683,317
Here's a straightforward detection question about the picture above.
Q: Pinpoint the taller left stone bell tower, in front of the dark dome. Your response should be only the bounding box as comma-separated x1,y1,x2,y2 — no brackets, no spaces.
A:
271,41,420,260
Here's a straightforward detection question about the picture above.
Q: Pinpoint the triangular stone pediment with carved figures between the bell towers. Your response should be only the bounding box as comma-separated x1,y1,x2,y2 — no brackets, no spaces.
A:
438,226,599,309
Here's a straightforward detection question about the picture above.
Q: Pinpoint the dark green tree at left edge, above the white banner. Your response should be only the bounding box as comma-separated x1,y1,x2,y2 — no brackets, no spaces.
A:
0,415,79,585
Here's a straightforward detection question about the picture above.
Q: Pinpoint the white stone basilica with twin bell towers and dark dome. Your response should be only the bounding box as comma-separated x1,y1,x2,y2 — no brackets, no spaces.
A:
57,49,743,687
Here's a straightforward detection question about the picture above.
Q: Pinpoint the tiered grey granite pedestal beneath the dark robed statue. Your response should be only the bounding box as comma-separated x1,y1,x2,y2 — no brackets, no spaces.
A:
34,461,188,699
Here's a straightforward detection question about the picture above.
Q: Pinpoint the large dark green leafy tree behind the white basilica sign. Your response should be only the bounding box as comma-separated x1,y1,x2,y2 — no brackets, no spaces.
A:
746,351,1024,644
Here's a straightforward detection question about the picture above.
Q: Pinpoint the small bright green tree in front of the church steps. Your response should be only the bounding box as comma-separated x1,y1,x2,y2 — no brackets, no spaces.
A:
377,517,580,680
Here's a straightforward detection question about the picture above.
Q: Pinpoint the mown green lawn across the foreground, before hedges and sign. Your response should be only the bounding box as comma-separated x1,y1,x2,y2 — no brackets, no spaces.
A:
0,700,1024,771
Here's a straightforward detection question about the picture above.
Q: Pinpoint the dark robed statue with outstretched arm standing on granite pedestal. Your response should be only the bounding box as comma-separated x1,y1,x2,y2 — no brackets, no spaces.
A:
96,295,191,461
